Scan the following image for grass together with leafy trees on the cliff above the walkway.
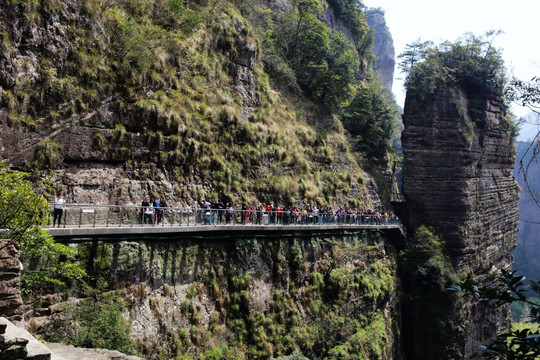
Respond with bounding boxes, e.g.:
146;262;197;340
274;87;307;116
2;0;384;205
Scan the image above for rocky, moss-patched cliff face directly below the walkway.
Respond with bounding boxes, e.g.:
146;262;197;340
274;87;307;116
39;232;399;359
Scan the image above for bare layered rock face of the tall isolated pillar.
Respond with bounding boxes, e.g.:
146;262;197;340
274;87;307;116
402;77;519;358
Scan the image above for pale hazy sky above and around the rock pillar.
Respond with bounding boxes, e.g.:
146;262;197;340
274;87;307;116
363;0;540;116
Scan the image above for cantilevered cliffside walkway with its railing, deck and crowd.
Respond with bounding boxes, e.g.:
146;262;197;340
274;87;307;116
47;204;404;242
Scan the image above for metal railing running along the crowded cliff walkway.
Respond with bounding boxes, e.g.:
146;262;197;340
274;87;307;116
49;204;401;227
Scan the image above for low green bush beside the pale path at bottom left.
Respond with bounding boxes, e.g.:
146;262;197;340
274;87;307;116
44;293;137;354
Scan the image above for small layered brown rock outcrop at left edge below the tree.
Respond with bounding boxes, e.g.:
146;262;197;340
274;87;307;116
0;240;23;320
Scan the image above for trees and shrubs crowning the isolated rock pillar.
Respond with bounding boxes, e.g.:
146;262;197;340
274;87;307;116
399;31;506;99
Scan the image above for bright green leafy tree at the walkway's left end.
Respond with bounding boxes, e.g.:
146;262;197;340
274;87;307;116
0;162;86;291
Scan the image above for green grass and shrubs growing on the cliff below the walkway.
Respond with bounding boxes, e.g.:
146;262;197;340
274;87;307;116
125;238;396;359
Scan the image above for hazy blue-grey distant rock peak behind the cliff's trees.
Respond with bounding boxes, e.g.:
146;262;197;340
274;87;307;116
366;9;396;91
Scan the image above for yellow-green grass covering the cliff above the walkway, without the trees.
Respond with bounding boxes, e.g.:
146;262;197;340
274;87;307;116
0;0;396;207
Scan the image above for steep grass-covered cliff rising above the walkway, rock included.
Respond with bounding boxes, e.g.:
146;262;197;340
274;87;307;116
0;0;388;207
